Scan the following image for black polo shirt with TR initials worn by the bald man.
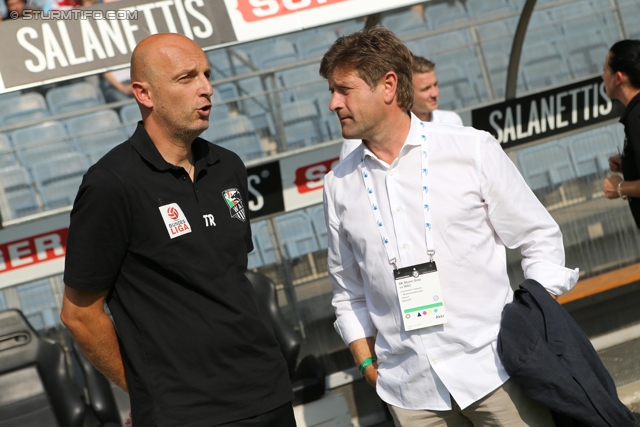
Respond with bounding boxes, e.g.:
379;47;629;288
64;124;293;427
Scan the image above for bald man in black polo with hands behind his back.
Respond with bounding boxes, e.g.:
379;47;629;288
61;34;295;427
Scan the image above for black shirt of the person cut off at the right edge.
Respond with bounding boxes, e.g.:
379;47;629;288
620;93;640;228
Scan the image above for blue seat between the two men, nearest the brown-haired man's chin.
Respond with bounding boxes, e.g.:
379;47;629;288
281;101;324;148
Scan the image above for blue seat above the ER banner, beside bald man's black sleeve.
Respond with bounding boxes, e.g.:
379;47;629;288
33;153;90;210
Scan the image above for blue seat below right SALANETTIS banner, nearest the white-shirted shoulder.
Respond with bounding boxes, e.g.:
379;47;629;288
518;142;576;191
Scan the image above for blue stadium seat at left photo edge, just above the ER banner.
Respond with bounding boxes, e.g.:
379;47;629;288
0;165;40;219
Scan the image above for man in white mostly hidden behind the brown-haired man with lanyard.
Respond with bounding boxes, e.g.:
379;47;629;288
340;55;462;160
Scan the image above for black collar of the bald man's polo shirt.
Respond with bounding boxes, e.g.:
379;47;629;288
129;121;219;171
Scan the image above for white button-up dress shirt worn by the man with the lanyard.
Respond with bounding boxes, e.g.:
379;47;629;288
324;114;578;410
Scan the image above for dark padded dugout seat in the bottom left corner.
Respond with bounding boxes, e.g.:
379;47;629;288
0;309;85;427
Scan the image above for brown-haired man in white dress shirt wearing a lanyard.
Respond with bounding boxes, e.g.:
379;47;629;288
320;27;578;427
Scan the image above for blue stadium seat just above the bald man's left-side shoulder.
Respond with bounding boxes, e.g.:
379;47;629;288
65;110;127;163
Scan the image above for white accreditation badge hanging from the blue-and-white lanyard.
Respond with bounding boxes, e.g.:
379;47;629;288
393;262;447;331
